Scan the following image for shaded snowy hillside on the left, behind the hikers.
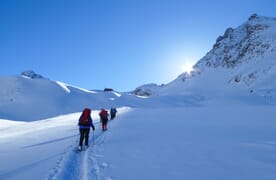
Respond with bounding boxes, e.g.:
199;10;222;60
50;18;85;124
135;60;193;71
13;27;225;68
0;72;126;121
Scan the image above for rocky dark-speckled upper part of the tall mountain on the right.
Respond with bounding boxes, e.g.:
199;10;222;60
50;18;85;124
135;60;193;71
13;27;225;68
196;14;276;70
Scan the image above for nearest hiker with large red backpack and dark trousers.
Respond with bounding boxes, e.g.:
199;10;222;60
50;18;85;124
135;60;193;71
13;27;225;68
78;108;95;150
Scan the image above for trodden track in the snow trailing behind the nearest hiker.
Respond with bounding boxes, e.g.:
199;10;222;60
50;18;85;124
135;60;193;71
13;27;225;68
46;123;112;180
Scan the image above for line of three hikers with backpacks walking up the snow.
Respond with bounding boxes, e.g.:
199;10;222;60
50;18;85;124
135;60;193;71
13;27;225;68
78;108;117;151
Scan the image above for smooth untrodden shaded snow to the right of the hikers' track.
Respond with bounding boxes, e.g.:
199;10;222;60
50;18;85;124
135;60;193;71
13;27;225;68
100;107;276;179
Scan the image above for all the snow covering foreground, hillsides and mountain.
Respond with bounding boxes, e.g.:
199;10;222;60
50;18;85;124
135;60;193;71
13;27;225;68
0;16;276;180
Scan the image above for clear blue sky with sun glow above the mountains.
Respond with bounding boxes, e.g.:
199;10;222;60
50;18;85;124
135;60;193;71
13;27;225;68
0;0;276;91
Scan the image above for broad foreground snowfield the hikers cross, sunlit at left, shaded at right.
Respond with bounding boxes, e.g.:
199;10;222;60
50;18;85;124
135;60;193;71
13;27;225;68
0;102;276;180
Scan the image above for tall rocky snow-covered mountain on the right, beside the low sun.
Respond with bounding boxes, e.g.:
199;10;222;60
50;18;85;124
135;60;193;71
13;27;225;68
134;14;276;97
